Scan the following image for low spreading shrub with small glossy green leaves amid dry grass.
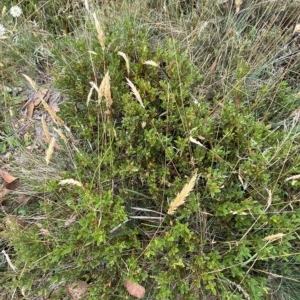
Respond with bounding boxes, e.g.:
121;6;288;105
3;0;300;299
